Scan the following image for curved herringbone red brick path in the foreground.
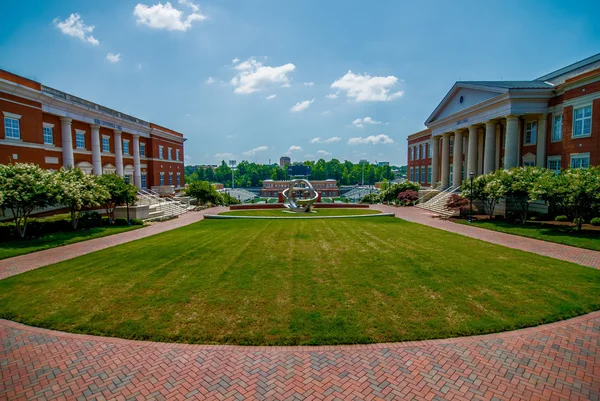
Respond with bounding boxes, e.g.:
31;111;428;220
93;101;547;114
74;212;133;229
0;312;600;400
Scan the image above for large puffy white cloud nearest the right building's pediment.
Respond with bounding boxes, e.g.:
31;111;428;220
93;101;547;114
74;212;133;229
331;71;404;102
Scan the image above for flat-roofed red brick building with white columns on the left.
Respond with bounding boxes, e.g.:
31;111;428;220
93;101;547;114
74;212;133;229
0;70;185;188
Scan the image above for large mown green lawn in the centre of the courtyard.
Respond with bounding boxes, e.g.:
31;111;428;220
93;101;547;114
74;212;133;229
0;218;600;344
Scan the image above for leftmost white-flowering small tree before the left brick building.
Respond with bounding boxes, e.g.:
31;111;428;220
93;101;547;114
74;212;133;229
0;163;57;238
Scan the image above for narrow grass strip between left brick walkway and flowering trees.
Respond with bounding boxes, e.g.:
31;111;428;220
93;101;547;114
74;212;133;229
0;226;141;259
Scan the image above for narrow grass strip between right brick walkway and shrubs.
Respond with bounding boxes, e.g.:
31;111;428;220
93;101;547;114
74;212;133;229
454;220;600;251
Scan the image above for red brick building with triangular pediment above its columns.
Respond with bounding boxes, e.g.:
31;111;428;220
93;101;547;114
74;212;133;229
408;54;600;188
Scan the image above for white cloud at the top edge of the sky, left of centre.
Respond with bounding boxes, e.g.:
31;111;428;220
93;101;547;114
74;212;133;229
133;0;206;31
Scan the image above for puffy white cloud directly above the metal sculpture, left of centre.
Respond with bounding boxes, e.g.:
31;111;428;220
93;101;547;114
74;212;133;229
231;58;296;94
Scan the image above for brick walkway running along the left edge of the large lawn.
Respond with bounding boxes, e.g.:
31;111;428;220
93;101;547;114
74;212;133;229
0;207;228;280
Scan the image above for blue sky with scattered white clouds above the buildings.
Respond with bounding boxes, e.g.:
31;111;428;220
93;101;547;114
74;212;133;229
0;0;600;164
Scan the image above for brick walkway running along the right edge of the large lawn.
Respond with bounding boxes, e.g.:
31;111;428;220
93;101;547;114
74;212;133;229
371;205;600;269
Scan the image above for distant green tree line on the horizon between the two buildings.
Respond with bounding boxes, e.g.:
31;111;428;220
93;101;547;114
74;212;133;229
185;159;406;188
